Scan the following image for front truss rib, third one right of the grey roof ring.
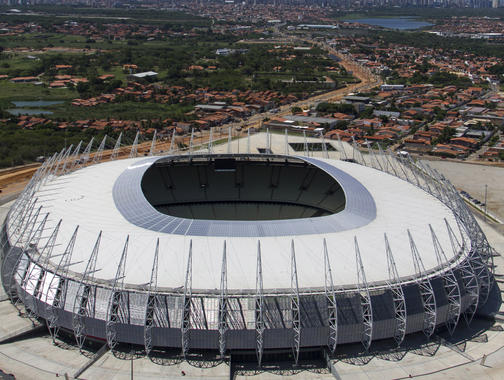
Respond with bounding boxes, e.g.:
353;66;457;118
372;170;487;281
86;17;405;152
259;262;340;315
429;224;462;335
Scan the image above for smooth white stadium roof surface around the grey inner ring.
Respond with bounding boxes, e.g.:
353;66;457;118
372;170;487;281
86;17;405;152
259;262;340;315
34;152;456;293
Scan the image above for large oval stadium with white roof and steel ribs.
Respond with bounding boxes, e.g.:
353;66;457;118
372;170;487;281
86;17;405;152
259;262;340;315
0;132;493;365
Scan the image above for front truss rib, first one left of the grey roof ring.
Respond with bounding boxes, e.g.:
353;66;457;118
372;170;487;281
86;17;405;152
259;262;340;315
72;231;102;350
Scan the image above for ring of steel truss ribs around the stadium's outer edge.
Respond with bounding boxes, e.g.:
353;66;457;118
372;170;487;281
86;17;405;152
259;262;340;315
2;134;500;360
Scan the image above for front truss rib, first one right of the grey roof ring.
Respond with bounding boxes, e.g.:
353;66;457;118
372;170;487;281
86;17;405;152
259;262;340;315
383;234;408;347
